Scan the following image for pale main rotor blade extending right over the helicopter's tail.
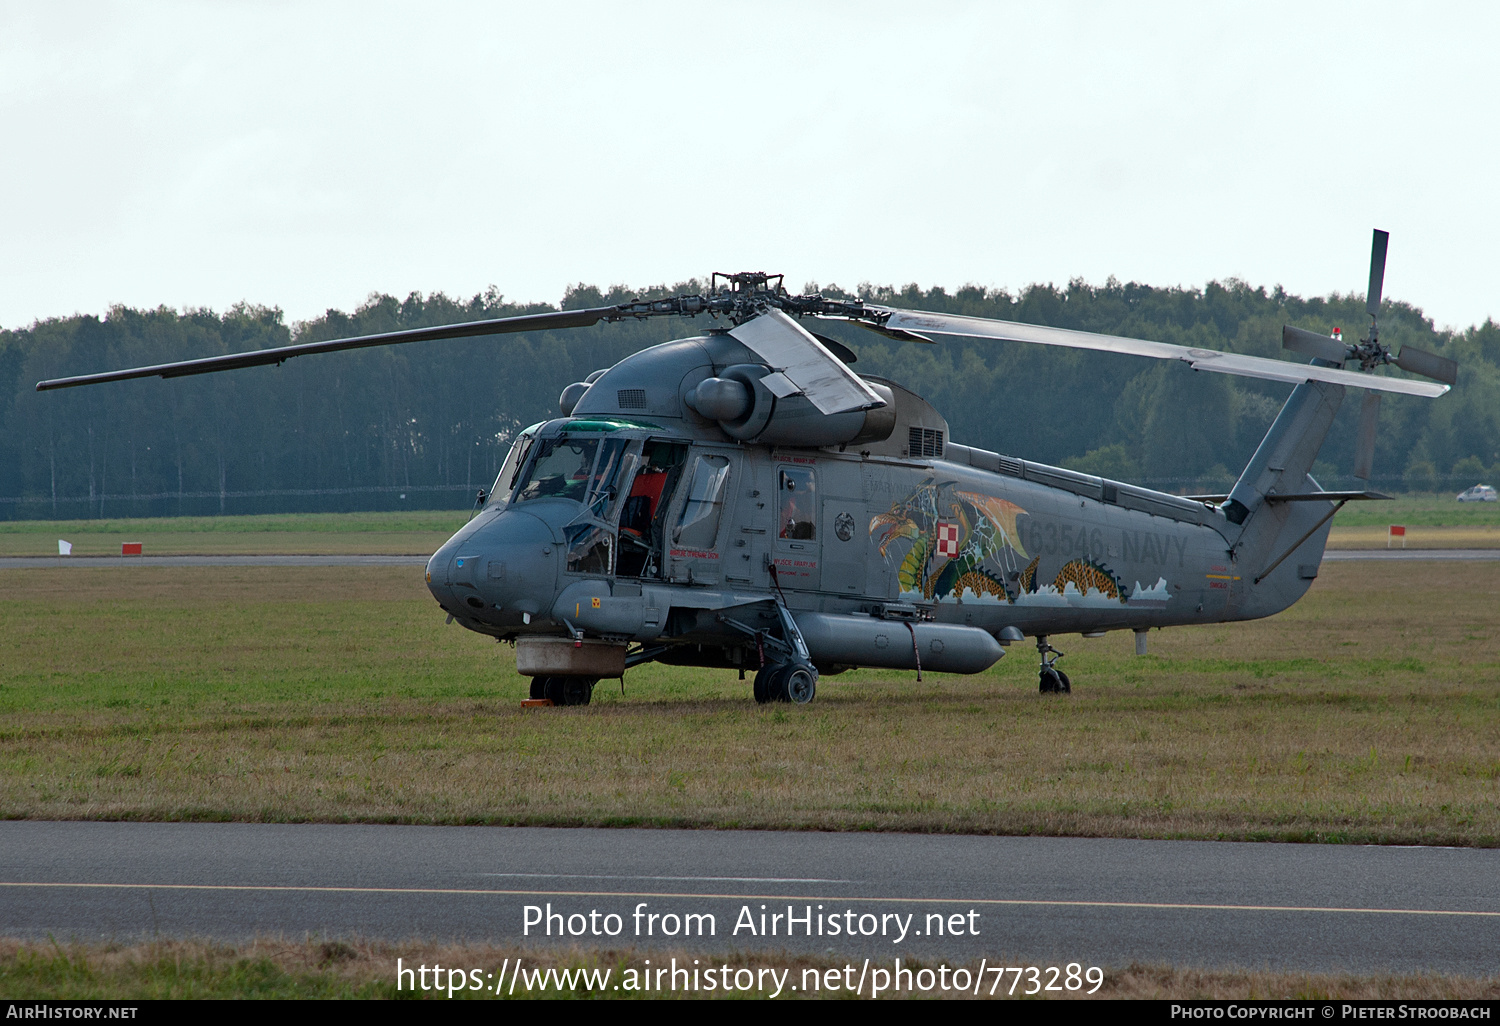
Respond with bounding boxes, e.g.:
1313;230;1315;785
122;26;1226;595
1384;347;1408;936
870;306;1448;398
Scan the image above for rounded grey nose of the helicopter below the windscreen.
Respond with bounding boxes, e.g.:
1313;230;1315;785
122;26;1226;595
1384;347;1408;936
428;510;561;626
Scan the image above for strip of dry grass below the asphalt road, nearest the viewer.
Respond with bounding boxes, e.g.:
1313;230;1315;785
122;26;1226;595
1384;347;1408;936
0;938;1500;1001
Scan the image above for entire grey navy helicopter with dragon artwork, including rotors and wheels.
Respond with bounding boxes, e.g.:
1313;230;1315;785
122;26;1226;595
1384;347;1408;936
36;230;1457;705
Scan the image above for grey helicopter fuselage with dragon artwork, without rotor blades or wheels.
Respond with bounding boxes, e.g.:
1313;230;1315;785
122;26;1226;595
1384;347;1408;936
428;333;1341;672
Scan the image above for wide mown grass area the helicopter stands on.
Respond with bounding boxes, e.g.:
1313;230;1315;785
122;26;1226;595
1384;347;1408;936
0;564;1500;846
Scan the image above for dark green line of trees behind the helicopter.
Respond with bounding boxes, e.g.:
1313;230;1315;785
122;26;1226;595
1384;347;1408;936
0;279;1500;519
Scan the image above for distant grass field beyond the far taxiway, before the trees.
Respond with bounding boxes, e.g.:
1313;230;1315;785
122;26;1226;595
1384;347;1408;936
0;494;1500;557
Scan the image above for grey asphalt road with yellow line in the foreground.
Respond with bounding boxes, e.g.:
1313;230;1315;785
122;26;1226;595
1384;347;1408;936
0;821;1500;975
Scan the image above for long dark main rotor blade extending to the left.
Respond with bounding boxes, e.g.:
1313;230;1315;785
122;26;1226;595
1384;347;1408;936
36;306;617;392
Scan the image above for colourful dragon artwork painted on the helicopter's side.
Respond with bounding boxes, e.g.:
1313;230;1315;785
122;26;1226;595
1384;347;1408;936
870;477;1127;603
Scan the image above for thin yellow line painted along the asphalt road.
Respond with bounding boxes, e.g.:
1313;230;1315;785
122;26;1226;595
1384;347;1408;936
0;881;1500;918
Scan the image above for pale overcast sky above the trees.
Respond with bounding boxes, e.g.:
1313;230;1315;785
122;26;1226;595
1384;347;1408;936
0;0;1500;327
